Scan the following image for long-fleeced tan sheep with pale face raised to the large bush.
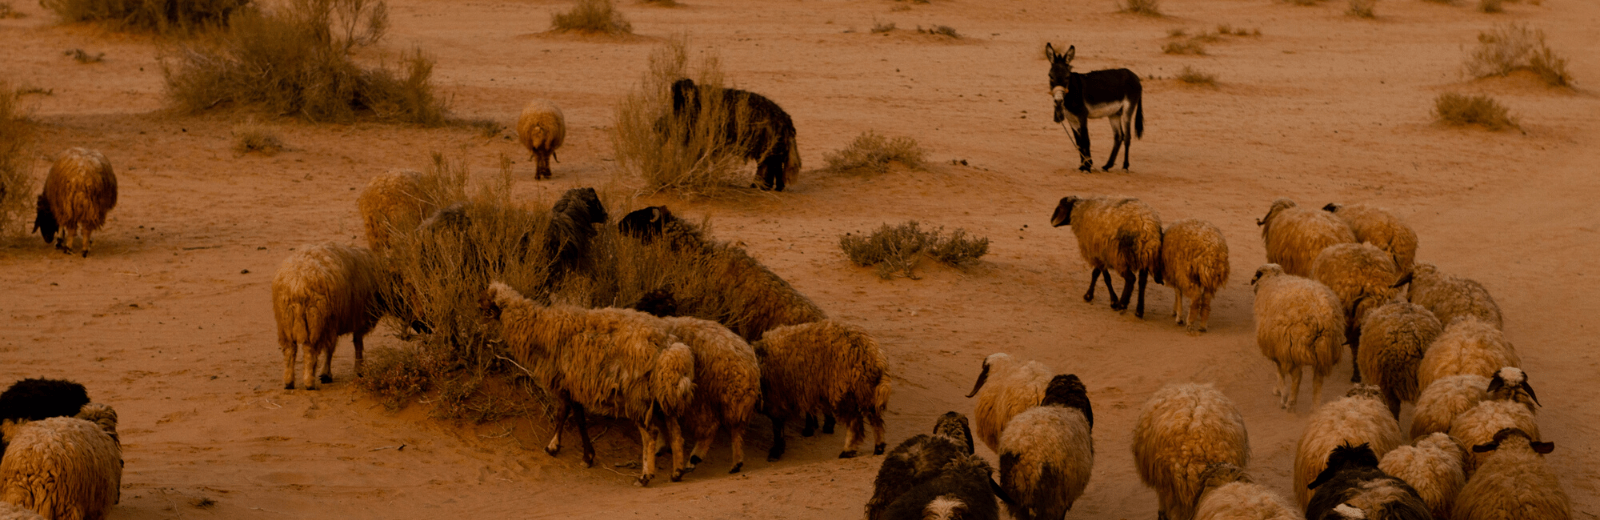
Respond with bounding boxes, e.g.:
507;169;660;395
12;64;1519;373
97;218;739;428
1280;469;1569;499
478;282;694;486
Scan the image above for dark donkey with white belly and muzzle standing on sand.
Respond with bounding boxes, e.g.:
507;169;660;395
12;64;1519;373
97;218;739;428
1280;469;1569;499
1045;43;1144;171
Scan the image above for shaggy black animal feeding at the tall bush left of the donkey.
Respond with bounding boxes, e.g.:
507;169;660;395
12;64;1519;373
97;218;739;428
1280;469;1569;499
672;78;800;192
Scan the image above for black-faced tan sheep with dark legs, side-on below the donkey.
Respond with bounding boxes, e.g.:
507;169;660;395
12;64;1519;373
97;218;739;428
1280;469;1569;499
1050;197;1163;318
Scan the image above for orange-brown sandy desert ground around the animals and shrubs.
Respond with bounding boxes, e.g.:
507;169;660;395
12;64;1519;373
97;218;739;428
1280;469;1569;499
0;0;1600;518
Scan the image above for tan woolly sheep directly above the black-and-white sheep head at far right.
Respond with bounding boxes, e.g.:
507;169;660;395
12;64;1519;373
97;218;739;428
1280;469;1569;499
1416;317;1522;390
